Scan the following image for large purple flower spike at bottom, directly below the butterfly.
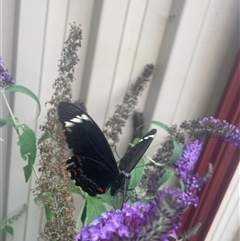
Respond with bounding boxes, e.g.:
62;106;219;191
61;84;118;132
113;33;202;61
75;192;186;241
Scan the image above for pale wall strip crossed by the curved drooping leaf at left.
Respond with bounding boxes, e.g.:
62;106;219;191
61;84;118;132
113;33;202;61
7;1;46;240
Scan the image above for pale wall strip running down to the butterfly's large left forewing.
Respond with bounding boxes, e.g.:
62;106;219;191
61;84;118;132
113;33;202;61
86;0;129;127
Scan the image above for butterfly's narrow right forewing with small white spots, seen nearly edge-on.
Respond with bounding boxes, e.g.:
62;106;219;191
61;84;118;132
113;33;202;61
119;129;157;173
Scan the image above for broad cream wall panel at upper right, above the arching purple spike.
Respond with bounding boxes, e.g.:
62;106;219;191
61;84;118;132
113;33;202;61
149;0;238;141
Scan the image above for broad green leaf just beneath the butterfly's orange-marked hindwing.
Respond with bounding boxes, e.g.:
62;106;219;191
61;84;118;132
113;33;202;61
86;196;106;224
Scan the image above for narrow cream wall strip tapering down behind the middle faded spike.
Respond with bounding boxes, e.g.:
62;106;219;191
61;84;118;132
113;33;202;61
108;0;147;115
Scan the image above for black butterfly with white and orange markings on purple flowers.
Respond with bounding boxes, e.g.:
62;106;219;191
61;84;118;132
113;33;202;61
58;102;157;196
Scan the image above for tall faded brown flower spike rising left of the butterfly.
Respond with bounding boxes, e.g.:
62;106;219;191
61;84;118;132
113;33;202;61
35;24;82;241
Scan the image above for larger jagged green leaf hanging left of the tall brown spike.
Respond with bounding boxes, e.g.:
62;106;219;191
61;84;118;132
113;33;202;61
17;125;37;165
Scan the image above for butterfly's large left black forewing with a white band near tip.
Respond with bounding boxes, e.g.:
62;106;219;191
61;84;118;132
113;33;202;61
58;102;118;175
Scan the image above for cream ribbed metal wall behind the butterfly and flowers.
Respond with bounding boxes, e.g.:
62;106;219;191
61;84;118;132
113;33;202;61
0;0;239;241
